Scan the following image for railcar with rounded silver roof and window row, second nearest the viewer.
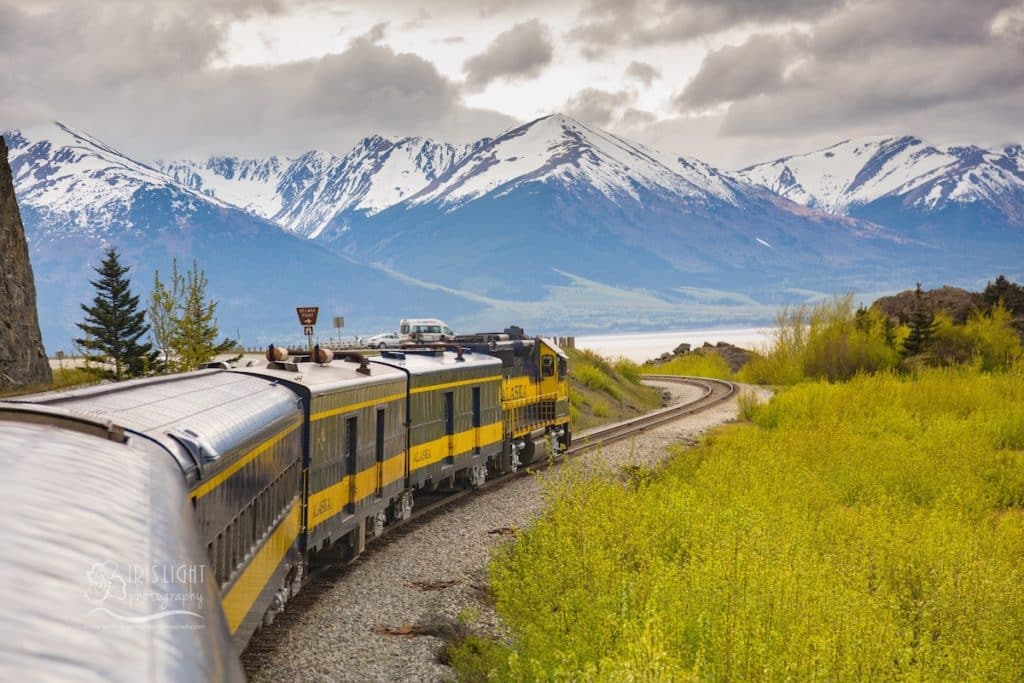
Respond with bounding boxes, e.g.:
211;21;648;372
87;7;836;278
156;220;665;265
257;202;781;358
12;371;305;650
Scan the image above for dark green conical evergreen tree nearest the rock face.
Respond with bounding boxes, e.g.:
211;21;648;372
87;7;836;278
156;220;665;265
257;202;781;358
75;247;156;380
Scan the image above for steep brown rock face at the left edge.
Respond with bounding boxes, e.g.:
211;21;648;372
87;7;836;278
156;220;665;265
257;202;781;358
0;137;52;392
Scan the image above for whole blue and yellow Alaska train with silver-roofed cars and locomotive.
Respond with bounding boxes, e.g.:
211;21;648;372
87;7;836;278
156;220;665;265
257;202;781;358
0;327;571;680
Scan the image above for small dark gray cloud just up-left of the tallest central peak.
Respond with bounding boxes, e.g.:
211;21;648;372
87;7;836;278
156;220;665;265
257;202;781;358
464;19;554;90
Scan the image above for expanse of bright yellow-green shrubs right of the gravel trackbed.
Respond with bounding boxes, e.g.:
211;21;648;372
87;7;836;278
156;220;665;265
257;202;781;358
460;364;1024;681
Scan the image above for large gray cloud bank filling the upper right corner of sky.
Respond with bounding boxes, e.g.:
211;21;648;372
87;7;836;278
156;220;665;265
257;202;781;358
674;0;1024;149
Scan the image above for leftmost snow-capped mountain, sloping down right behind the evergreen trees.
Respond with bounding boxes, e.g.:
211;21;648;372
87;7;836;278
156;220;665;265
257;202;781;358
4;124;479;351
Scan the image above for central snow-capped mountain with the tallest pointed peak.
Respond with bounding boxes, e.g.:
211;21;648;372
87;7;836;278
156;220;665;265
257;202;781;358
319;115;913;297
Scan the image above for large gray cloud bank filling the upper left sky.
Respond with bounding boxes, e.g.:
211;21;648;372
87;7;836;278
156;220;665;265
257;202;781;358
0;0;515;161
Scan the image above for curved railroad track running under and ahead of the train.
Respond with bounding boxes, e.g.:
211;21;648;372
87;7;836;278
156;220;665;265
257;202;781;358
242;375;735;677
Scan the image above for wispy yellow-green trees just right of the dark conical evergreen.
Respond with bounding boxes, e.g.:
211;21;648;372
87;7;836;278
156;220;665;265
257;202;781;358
150;260;236;371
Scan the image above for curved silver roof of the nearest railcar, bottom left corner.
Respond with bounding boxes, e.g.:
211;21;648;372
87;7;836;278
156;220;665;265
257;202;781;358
0;413;243;682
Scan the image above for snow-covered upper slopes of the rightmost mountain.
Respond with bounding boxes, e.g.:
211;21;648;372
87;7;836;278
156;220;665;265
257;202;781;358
740;136;1024;225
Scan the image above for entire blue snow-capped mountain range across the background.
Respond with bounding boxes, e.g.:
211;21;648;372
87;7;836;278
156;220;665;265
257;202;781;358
5;115;1024;346
